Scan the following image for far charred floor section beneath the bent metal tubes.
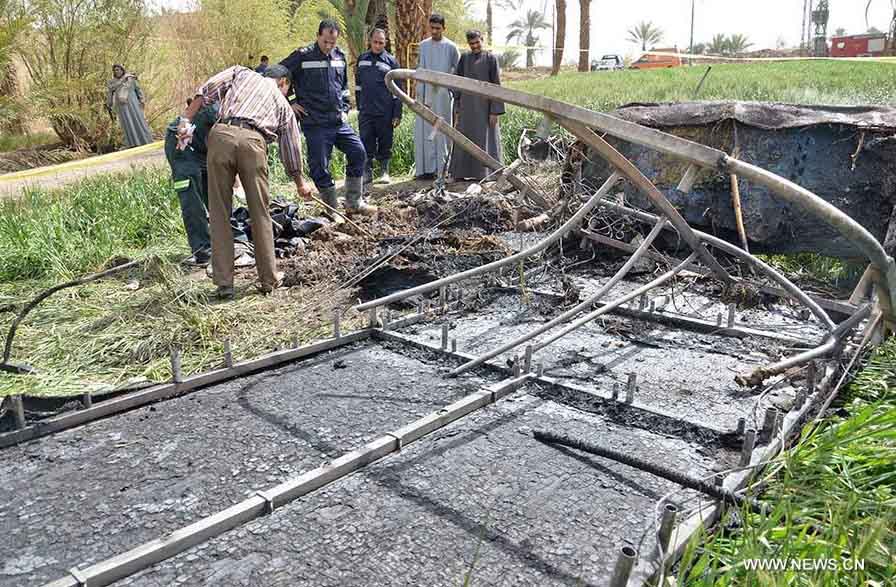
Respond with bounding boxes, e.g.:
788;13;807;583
406;282;780;432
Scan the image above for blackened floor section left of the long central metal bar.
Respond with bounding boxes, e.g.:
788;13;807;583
0;345;496;586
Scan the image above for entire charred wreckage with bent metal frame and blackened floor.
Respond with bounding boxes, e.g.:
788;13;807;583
0;70;896;587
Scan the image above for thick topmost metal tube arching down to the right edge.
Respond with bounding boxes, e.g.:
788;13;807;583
386;69;896;300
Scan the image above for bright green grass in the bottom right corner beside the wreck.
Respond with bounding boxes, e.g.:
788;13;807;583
676;339;896;587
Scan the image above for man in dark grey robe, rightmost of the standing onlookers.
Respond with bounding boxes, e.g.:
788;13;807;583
450;31;504;180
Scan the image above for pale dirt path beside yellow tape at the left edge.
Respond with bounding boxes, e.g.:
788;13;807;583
0;141;165;198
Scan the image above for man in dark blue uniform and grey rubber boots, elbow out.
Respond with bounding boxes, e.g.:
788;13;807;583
281;20;376;214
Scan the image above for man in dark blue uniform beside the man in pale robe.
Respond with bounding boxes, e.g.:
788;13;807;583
355;29;401;183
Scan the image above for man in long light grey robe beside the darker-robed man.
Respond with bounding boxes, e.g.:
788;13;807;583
414;13;460;179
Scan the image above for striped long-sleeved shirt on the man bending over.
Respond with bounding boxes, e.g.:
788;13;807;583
196;65;302;178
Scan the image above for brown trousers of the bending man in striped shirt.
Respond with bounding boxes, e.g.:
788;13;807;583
208;124;277;287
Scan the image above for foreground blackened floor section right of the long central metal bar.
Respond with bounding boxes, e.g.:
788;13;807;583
120;391;732;587
